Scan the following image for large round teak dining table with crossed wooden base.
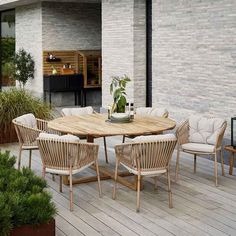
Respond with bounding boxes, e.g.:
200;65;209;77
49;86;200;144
48;113;176;190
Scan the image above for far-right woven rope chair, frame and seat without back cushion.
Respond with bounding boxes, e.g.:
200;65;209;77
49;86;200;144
175;116;227;186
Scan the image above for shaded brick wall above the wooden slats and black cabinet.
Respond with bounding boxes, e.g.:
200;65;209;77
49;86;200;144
42;2;101;50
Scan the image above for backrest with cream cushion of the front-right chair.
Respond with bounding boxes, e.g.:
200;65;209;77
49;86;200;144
115;134;177;171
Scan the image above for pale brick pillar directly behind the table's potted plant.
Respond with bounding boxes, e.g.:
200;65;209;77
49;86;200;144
102;0;146;106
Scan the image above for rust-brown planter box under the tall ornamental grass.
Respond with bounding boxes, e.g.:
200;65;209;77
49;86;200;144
0;123;18;144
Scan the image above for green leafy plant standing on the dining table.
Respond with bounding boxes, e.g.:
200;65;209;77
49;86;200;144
110;75;131;113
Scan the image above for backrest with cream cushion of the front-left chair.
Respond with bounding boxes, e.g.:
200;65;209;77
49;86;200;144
37;135;99;170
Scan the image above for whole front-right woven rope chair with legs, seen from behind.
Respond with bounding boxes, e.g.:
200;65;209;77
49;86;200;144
113;137;177;212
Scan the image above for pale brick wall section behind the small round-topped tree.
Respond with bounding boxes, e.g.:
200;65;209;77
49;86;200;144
16;3;43;96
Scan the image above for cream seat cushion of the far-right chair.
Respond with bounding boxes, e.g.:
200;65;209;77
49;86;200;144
181;143;215;153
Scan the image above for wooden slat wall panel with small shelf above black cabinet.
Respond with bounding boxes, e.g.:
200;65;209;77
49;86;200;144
43;51;78;75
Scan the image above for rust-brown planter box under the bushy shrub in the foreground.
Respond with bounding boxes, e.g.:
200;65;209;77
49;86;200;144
10;219;55;236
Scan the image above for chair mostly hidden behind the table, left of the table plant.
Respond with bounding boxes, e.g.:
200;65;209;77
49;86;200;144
61;106;108;163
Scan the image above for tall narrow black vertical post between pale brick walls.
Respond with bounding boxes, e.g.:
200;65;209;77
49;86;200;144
146;0;152;107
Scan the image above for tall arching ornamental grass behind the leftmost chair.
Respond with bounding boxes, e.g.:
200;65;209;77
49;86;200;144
0;88;51;124
